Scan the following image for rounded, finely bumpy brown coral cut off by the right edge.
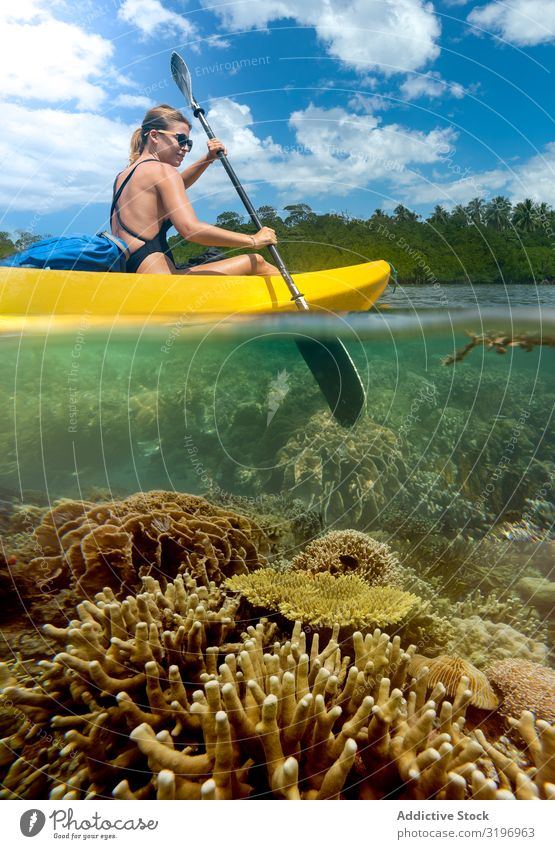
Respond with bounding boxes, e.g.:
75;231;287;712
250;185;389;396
485;658;555;722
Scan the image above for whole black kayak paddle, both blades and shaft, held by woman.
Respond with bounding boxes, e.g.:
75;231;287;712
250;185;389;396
171;53;365;427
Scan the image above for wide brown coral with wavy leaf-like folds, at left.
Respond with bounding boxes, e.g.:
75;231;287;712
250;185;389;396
30;491;266;595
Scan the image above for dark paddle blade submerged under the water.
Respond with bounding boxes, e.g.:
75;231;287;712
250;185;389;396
295;338;366;427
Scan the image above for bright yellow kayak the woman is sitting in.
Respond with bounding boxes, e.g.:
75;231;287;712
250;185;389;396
0;260;391;327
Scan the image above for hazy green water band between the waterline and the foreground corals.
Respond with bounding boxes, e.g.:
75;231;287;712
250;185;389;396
0;308;555;532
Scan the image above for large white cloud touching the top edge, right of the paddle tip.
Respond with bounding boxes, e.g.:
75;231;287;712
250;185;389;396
202;0;440;74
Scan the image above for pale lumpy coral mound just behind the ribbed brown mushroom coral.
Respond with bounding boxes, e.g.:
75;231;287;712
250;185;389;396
447;616;547;669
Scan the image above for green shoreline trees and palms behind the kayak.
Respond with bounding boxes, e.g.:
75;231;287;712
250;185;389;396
4;195;555;285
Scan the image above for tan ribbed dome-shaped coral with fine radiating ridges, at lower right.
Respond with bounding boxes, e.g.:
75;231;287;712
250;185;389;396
409;654;499;710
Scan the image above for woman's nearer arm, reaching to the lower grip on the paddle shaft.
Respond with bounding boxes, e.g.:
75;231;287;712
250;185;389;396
156;163;277;248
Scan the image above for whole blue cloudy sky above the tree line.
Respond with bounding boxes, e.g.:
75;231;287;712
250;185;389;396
0;0;555;234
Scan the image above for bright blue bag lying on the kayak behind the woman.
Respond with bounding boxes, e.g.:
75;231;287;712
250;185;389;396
0;231;129;271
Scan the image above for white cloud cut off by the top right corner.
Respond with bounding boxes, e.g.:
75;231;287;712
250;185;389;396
467;0;555;47
